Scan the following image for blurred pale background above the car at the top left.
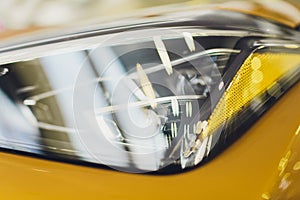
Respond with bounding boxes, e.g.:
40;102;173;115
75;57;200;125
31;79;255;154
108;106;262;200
0;0;299;31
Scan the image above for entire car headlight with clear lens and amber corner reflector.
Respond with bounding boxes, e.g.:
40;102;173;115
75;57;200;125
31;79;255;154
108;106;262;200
0;10;300;172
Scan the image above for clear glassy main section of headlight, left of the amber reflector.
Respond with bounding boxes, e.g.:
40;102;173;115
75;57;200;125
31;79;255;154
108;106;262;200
0;33;233;172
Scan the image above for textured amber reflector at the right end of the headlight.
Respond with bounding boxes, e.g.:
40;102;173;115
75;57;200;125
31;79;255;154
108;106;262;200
202;53;300;138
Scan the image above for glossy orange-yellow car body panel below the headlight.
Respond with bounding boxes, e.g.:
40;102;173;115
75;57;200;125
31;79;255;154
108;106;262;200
0;84;300;200
